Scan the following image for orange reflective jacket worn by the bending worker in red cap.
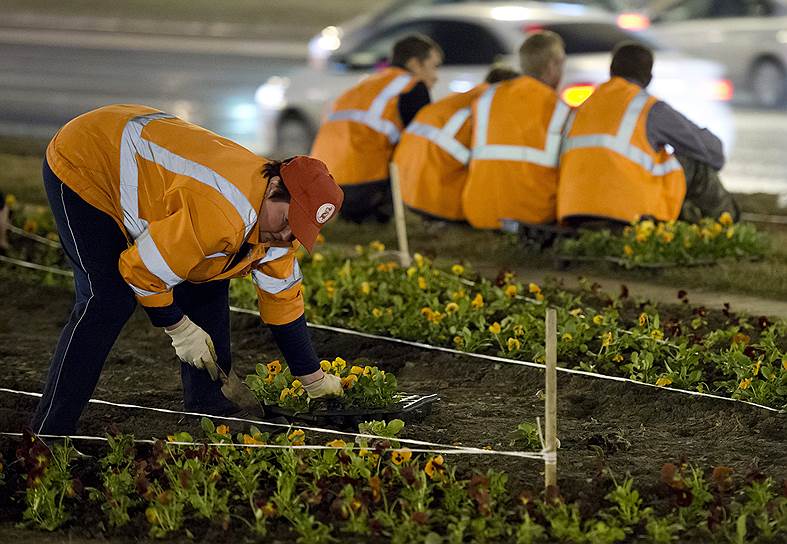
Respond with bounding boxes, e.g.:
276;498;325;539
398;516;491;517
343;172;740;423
46;105;303;325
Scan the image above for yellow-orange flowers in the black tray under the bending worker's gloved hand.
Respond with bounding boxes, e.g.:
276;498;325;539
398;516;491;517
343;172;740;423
246;357;396;413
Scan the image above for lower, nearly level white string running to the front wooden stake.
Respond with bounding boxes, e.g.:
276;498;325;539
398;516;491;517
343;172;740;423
0;434;544;460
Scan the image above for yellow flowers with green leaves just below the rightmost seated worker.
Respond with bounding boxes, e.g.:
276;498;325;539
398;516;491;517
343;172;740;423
558;216;768;268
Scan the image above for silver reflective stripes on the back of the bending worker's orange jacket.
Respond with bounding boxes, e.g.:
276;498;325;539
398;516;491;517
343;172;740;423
120;113;257;296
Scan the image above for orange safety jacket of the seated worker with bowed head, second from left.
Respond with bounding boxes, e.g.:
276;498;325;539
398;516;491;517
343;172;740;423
393;83;488;221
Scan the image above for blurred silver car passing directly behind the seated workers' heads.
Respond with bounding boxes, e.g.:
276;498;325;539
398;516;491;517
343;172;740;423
255;2;733;156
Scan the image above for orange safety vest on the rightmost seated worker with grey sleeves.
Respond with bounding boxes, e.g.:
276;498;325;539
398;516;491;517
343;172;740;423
557;77;686;222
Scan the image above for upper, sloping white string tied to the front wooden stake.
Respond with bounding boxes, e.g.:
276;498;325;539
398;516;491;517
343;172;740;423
0;387;543;459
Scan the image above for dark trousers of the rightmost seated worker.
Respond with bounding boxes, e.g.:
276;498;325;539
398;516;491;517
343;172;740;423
675;154;740;223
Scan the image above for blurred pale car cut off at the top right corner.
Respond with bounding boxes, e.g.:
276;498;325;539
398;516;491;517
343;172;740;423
650;0;787;107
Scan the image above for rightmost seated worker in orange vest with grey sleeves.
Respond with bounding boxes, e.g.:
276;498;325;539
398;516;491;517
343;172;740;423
557;42;738;226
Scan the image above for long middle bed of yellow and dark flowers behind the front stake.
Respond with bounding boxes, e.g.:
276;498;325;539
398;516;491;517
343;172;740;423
232;243;787;408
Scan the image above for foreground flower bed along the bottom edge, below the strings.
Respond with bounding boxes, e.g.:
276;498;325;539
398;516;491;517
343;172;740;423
0;419;787;543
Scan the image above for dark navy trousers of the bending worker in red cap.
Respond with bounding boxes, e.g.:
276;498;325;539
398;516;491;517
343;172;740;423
31;161;234;434
